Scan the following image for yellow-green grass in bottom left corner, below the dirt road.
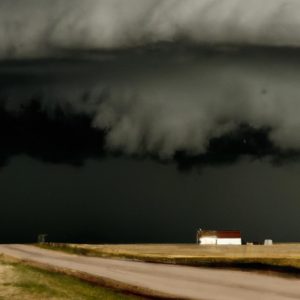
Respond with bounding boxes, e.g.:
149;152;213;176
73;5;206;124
0;256;140;300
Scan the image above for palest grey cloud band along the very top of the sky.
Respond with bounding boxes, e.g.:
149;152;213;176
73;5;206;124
0;0;300;58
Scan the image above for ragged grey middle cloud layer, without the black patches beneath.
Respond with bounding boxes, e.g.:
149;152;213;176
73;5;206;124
0;46;300;159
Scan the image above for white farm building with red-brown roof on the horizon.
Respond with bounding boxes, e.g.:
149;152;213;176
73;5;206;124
197;229;242;245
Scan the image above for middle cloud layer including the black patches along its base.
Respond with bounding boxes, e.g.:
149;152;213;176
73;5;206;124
0;44;300;169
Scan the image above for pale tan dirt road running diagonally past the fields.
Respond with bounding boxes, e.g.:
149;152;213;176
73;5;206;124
0;245;300;300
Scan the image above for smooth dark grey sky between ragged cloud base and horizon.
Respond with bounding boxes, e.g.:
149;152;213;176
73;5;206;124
0;156;300;243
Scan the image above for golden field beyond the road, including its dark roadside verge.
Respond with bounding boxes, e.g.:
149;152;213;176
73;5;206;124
38;243;300;274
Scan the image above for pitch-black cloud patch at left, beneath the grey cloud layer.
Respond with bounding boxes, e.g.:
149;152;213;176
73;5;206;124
0;100;104;167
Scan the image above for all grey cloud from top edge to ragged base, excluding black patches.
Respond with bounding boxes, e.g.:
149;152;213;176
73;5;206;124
0;0;300;163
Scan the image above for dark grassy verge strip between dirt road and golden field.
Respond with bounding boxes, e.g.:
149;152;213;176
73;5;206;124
35;243;300;276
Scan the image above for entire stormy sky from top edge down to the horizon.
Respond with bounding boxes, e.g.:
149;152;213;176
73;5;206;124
0;0;300;243
